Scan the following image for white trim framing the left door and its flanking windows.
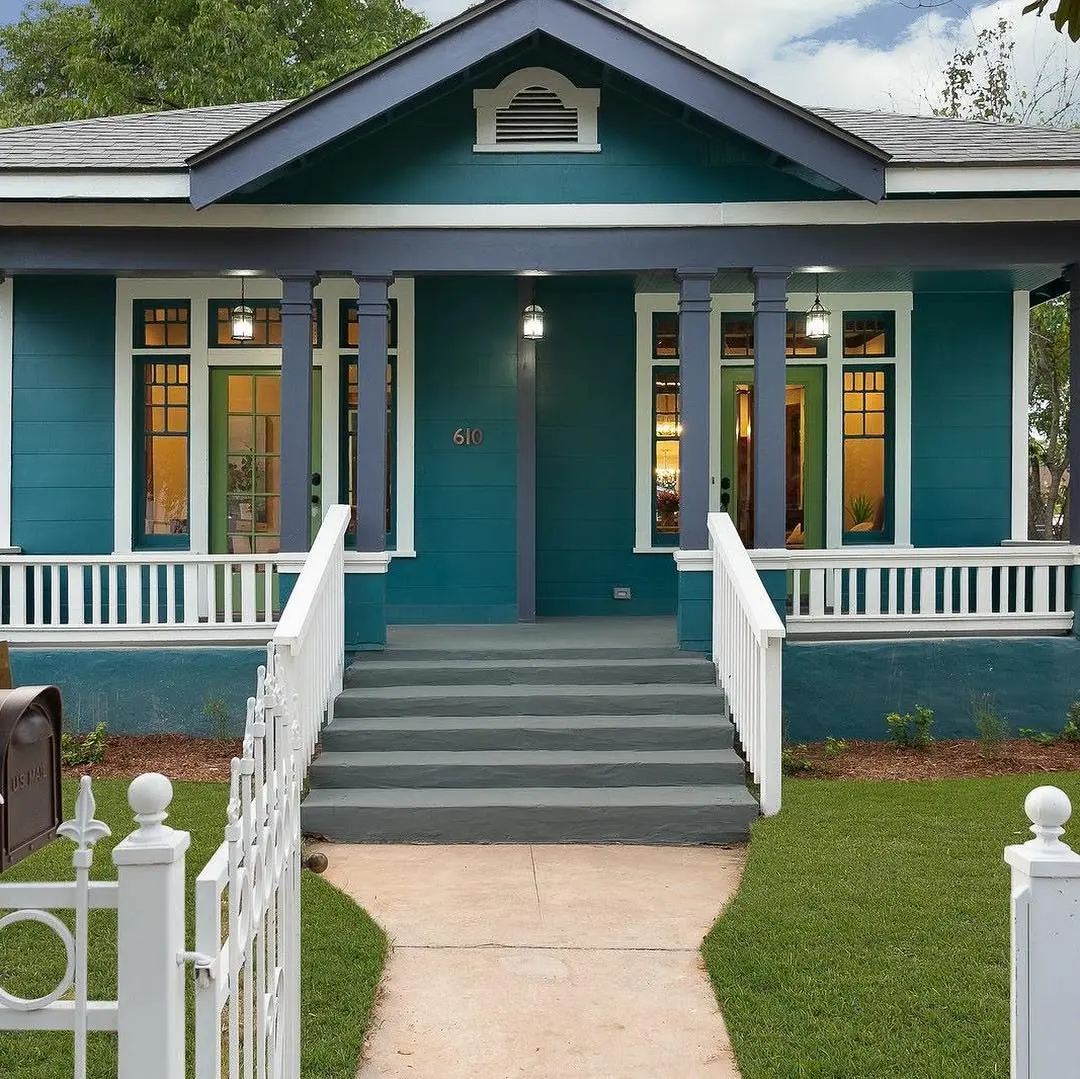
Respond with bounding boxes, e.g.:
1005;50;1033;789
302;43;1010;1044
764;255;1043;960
111;277;415;558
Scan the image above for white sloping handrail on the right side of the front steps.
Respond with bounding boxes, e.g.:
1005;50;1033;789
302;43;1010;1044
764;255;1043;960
708;513;785;817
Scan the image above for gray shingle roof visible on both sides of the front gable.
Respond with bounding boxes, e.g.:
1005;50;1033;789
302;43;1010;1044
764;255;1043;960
0;102;1080;171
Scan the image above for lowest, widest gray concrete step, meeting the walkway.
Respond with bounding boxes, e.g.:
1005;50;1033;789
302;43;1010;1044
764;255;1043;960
301;784;758;846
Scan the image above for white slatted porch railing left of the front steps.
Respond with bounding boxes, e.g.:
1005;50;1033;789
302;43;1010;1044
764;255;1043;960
0;552;302;644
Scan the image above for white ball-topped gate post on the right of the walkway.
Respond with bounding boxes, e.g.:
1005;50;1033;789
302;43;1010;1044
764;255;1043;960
1004;786;1080;1079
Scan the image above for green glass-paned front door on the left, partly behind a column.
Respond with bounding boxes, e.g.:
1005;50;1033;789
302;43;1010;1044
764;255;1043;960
210;367;322;554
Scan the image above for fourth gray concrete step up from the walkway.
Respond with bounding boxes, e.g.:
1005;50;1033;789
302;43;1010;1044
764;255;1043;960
334;685;725;717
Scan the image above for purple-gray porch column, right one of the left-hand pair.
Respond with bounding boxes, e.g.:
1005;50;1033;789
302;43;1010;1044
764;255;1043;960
354;273;393;552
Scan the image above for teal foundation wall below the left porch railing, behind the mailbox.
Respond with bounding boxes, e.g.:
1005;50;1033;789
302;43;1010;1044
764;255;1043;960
11;647;267;737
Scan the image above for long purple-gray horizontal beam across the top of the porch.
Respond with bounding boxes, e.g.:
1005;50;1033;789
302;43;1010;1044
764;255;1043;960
14;221;1080;274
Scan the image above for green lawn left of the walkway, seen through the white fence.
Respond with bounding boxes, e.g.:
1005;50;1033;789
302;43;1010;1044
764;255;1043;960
0;779;387;1079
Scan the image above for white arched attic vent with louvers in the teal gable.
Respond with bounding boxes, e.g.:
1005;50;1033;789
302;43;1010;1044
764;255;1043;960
473;67;600;153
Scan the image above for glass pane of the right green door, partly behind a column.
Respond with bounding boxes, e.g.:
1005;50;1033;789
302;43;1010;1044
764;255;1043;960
734;383;807;548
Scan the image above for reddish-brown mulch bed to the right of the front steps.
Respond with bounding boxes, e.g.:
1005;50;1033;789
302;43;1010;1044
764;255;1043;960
793;739;1080;780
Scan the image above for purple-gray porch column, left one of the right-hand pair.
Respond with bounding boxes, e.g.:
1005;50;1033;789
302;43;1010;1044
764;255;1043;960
678;269;716;551
